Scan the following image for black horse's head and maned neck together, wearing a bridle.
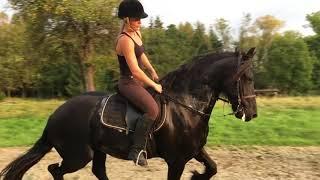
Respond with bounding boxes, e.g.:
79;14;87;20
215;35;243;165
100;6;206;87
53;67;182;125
161;48;257;121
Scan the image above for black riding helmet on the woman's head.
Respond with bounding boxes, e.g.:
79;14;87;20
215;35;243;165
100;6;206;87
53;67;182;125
118;0;148;19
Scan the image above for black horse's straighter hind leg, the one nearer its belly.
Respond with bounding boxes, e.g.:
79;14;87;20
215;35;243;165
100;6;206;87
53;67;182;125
92;150;108;180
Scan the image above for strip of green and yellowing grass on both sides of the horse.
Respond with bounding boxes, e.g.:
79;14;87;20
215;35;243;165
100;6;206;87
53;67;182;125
0;96;320;147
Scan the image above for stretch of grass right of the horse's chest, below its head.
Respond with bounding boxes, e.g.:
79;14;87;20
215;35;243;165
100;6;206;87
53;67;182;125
207;97;320;146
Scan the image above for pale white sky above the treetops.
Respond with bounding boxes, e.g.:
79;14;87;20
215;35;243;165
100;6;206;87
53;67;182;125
0;0;320;35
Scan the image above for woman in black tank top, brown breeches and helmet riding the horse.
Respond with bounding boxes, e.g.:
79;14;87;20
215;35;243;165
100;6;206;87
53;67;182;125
116;0;162;166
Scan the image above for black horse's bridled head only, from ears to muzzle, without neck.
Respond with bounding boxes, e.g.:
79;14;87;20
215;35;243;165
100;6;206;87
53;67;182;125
222;48;257;121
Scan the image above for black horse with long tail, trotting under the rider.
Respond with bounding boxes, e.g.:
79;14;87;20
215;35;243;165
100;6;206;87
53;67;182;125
0;48;257;180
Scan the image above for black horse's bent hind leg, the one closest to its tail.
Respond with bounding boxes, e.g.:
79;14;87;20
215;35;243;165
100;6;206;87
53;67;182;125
48;149;92;180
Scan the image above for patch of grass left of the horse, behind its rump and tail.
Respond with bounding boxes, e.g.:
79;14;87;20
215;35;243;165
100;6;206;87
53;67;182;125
0;98;63;147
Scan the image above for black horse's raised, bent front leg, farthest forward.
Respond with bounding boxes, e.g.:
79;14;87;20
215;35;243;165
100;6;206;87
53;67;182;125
191;148;217;180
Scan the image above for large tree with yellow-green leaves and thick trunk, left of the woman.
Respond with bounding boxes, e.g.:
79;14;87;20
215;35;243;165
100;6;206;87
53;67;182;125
10;0;118;91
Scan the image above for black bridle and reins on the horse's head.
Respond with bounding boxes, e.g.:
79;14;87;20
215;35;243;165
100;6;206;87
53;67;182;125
160;53;256;118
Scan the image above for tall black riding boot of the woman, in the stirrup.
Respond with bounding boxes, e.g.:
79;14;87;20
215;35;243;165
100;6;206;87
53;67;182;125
128;116;153;166
